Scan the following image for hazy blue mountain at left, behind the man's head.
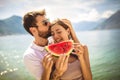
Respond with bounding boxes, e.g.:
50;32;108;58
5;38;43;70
0;15;26;35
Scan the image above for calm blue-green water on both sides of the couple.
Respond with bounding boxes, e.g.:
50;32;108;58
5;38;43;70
0;30;120;80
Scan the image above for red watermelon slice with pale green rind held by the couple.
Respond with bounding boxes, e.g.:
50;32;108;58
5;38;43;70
45;40;73;56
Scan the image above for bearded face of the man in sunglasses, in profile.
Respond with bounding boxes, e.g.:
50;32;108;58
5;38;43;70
36;16;50;38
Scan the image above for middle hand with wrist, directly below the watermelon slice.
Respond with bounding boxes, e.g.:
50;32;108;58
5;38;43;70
53;54;69;77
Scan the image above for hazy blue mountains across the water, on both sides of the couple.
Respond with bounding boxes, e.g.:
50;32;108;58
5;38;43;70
0;10;120;35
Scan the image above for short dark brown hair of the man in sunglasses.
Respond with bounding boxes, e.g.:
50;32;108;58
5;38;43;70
23;10;46;35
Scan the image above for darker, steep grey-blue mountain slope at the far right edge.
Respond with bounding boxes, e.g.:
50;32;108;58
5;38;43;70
95;10;120;30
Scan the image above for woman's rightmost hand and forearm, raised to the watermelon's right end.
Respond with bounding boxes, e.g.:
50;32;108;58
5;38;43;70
74;43;92;80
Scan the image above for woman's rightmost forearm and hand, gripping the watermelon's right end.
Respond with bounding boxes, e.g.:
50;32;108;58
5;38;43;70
75;44;92;80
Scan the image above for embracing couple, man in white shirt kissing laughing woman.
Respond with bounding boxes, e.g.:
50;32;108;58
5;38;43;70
23;10;92;80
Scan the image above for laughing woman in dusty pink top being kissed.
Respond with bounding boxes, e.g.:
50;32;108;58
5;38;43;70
42;20;92;80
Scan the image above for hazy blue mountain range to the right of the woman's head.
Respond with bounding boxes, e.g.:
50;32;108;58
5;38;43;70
73;10;120;31
